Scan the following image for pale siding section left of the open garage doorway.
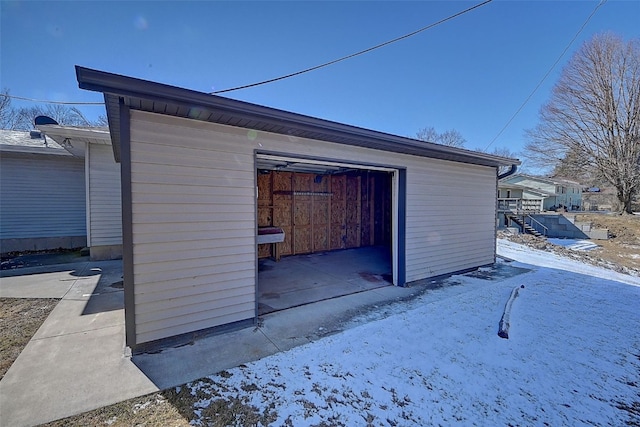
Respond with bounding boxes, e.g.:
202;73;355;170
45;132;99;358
131;112;256;343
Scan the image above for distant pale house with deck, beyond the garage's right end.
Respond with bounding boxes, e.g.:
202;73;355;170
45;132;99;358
498;174;582;224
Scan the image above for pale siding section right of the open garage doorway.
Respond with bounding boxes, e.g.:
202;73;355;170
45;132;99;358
406;161;497;281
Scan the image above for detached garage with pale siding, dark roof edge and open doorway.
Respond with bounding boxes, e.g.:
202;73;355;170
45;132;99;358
76;67;518;351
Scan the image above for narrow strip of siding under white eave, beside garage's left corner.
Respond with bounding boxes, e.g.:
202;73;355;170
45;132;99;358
88;144;122;247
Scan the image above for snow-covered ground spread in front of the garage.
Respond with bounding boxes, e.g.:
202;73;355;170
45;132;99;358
187;240;640;426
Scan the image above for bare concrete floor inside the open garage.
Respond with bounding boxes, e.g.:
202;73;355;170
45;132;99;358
258;246;392;315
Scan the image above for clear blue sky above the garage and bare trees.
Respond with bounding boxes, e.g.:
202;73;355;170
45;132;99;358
0;0;640;161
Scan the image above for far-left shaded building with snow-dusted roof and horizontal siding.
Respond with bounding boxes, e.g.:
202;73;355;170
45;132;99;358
0;130;87;254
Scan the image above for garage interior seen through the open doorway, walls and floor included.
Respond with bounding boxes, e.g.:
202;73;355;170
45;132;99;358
256;156;393;315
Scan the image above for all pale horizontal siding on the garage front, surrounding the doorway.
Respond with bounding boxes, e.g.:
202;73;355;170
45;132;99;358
131;111;496;343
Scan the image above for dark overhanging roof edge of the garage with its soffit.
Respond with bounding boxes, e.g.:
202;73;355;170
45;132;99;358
76;66;520;167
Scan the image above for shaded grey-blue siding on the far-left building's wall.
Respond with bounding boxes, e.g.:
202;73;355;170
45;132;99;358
0;152;87;239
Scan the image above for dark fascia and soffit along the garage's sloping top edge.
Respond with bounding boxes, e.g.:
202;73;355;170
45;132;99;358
76;66;520;167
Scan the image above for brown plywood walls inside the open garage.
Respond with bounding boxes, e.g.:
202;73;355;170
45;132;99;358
258;171;391;258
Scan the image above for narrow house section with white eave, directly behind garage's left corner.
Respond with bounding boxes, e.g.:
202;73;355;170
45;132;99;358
37;125;122;260
